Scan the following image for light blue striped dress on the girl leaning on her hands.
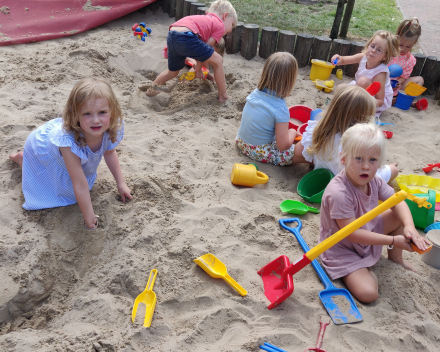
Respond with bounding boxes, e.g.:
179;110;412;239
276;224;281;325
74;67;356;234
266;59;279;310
22;118;124;210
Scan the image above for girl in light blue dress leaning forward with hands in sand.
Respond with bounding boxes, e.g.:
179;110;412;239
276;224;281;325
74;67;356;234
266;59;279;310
9;78;132;230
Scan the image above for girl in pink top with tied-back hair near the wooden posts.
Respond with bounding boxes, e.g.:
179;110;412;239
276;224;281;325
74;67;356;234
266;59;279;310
388;17;424;105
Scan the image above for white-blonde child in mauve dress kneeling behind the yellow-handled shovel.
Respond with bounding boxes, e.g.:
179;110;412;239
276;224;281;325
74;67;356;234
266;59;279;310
319;123;429;303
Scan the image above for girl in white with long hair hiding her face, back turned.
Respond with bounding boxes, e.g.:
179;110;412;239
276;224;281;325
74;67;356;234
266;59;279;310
293;85;399;182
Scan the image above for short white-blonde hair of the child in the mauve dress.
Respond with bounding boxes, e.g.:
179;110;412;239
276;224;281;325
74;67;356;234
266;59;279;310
339;123;386;168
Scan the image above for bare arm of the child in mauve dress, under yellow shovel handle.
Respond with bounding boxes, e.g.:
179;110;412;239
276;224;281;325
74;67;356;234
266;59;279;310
336;217;417;252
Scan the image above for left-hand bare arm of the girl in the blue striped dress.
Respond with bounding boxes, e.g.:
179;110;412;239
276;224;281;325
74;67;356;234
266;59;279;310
60;147;96;228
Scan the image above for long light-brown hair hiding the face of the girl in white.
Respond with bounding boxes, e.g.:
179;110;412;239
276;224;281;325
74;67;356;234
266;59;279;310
307;85;376;160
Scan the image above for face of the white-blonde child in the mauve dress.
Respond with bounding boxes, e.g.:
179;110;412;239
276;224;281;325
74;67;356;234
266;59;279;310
341;147;380;193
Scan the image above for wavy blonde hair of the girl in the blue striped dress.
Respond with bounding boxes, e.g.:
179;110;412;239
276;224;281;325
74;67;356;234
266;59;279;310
63;77;122;146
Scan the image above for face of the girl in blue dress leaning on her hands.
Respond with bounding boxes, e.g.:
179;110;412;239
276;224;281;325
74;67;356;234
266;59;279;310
79;98;111;140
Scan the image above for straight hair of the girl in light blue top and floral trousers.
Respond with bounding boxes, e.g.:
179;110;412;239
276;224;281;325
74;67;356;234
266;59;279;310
258;52;298;98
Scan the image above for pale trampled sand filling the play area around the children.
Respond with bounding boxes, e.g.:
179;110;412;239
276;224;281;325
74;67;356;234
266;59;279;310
0;6;440;352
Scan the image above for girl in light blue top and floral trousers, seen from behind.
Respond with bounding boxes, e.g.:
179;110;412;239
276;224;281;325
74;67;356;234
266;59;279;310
235;52;299;166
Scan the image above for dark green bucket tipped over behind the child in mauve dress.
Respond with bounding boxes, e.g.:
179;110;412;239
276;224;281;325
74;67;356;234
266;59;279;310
297;169;335;203
